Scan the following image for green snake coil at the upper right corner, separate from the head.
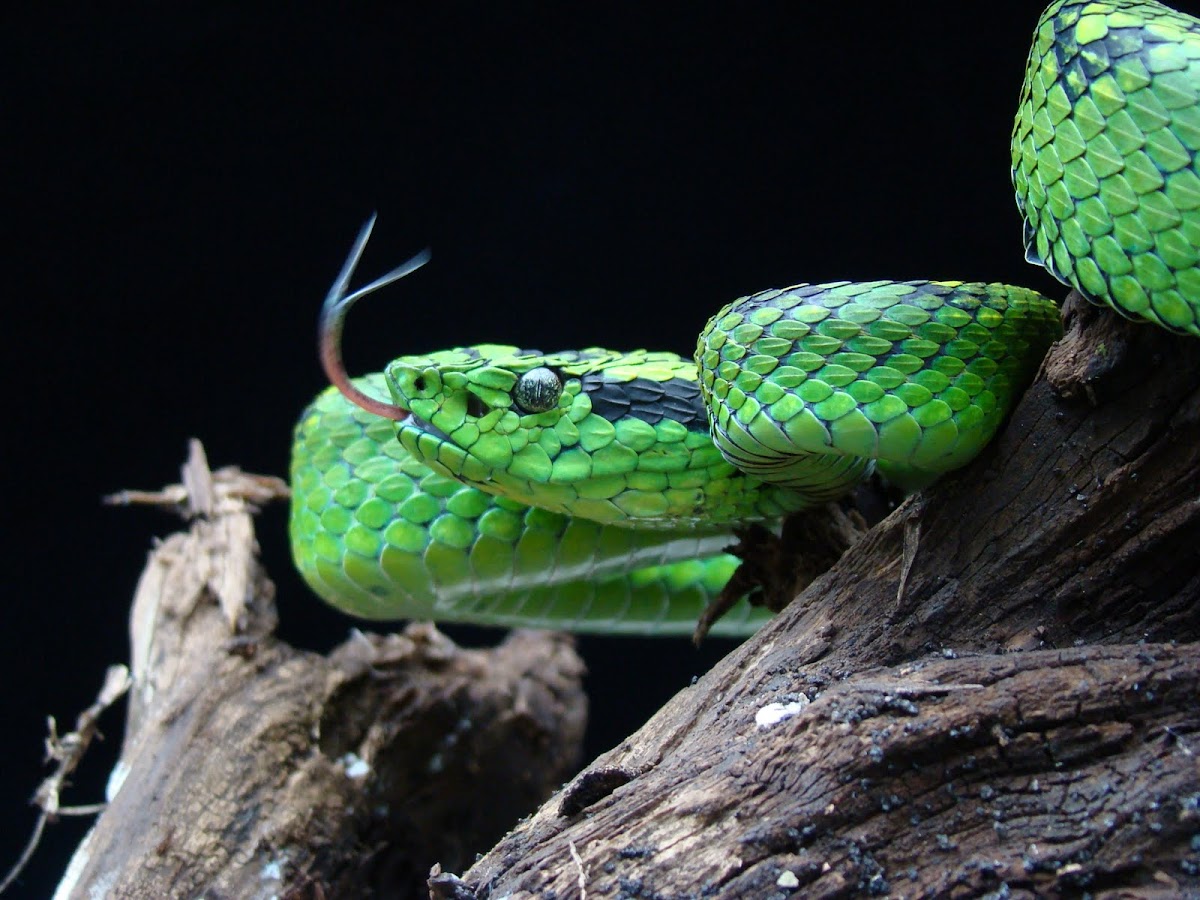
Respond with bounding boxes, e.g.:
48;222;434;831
1012;0;1200;336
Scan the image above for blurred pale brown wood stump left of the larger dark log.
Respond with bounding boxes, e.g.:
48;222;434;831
56;454;587;899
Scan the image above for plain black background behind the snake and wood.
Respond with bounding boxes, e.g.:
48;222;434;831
0;1;1123;896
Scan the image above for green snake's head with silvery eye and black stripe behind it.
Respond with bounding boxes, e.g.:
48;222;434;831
385;344;792;528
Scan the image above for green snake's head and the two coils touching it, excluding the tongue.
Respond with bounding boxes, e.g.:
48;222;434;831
292;282;1058;634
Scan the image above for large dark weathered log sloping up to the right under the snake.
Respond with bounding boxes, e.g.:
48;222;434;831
448;295;1200;899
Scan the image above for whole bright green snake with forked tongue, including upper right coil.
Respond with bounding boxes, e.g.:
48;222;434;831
290;0;1200;635
